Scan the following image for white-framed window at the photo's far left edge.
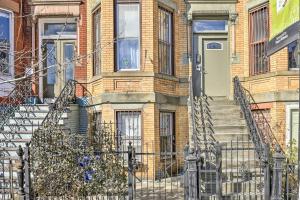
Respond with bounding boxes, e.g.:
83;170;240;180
0;9;14;74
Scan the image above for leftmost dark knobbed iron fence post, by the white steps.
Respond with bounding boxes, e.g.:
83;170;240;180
16;146;25;200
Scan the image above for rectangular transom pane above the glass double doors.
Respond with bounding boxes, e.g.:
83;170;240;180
44;23;77;35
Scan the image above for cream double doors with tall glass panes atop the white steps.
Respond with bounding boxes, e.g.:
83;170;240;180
43;40;75;99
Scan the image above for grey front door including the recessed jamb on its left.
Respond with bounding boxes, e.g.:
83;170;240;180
194;35;230;96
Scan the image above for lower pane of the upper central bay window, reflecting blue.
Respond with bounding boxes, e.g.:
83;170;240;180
118;38;140;69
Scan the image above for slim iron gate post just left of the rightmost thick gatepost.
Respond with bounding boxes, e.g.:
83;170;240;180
263;144;271;199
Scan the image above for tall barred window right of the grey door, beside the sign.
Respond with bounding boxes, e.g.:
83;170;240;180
249;5;270;75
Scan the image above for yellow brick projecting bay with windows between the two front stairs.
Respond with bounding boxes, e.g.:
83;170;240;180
87;0;190;175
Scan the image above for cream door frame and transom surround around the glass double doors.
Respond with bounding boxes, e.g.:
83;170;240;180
38;17;79;102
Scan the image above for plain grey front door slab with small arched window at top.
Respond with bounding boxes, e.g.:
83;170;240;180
202;39;230;96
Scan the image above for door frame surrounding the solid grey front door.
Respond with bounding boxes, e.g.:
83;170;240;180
192;32;231;97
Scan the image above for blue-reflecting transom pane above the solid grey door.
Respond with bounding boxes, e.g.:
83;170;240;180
193;20;227;33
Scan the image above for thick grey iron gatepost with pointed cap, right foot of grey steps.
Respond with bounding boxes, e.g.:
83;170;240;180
271;146;284;200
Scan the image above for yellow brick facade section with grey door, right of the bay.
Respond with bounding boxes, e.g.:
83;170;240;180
188;0;299;149
